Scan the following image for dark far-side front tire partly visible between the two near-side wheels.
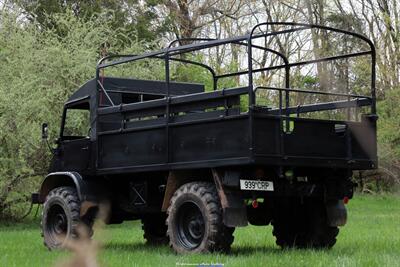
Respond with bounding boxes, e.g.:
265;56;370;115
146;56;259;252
142;213;169;246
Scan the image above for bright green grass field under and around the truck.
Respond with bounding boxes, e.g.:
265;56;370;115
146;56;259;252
0;195;400;267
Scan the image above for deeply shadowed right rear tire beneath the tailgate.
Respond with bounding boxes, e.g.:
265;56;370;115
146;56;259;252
272;199;339;249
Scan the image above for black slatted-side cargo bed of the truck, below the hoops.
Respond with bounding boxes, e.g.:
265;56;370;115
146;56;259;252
97;87;376;173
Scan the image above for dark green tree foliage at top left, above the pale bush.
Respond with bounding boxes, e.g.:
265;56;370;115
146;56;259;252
15;0;167;42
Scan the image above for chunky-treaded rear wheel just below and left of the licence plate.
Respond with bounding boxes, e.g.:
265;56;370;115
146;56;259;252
166;182;235;253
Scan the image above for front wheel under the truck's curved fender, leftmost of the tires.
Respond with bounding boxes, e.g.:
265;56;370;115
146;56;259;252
41;187;94;250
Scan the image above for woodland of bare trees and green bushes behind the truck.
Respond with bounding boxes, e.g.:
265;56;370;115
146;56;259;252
0;0;400;220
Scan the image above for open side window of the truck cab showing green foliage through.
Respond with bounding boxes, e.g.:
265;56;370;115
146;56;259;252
63;103;90;140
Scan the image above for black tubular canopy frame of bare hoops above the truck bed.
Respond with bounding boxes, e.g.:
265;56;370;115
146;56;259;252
96;22;376;116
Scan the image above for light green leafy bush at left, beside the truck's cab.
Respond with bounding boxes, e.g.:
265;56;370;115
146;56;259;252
0;12;159;218
